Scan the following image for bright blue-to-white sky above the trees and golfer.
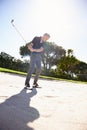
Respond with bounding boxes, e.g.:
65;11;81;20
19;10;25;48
0;0;87;62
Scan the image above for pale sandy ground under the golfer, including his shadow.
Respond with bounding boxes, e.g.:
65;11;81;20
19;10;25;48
0;73;87;130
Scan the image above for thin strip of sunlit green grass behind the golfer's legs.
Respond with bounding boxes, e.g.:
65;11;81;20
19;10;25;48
0;67;87;84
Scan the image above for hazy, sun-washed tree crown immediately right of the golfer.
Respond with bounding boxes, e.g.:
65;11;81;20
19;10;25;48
42;42;65;70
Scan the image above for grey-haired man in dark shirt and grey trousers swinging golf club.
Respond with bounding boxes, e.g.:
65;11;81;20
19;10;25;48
25;33;50;89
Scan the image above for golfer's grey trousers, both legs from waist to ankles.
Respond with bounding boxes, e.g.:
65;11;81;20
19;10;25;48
25;54;41;84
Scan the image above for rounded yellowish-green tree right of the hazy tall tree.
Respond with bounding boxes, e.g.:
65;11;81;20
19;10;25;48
57;49;79;78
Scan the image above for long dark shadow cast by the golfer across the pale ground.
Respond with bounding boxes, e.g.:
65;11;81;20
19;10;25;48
0;89;40;130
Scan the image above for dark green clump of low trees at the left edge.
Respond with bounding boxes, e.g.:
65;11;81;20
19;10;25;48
0;52;29;72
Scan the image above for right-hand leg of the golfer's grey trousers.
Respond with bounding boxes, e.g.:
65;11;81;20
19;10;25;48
34;58;41;83
